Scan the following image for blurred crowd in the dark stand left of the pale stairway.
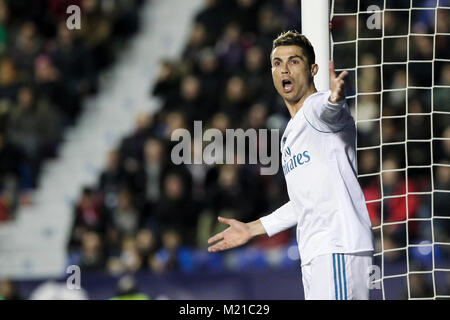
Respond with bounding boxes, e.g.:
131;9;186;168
0;0;143;222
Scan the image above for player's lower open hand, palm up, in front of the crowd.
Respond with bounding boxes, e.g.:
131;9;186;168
208;217;252;252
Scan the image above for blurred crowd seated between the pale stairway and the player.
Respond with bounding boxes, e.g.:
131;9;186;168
70;0;300;273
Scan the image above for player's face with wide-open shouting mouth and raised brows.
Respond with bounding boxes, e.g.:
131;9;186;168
271;46;318;103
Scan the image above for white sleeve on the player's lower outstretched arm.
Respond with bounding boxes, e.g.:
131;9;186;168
260;201;298;237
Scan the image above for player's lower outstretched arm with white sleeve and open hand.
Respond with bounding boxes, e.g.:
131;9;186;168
208;201;297;252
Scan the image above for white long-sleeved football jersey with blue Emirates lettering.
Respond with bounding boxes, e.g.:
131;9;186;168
261;91;374;265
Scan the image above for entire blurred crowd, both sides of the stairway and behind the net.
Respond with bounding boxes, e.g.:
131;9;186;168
0;0;450;300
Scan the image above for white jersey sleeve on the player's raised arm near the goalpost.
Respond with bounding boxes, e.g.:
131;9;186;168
303;91;352;133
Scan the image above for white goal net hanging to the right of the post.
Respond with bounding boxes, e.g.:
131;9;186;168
330;0;450;299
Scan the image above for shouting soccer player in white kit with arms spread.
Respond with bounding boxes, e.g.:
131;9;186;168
208;31;374;300
